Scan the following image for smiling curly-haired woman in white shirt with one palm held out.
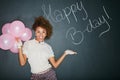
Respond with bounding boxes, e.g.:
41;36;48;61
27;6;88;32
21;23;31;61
18;16;75;80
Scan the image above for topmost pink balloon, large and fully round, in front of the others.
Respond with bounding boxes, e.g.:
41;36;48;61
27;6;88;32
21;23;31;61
10;20;25;37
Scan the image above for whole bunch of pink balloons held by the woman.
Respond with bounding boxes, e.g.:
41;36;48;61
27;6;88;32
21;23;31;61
0;20;32;53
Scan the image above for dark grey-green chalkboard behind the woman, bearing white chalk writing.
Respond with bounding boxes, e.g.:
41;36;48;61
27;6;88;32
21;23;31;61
0;0;120;80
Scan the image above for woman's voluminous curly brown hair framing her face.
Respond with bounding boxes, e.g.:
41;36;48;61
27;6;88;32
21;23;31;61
32;16;53;39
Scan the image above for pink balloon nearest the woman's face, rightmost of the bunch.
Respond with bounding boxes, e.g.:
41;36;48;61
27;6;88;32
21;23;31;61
20;28;32;41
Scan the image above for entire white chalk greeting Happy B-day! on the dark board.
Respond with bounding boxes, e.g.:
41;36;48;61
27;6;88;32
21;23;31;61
42;1;111;45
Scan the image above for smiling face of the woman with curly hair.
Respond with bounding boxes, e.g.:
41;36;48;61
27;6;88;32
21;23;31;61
35;26;47;42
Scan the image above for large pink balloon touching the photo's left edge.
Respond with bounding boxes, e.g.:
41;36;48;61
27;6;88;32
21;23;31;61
0;34;15;50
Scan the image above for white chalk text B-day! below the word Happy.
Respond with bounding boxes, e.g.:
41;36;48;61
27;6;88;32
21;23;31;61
66;6;111;45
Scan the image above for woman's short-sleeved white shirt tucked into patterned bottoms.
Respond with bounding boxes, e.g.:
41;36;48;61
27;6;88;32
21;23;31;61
23;39;54;73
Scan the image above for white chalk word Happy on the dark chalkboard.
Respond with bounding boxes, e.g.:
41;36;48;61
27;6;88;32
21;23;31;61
42;1;88;24
